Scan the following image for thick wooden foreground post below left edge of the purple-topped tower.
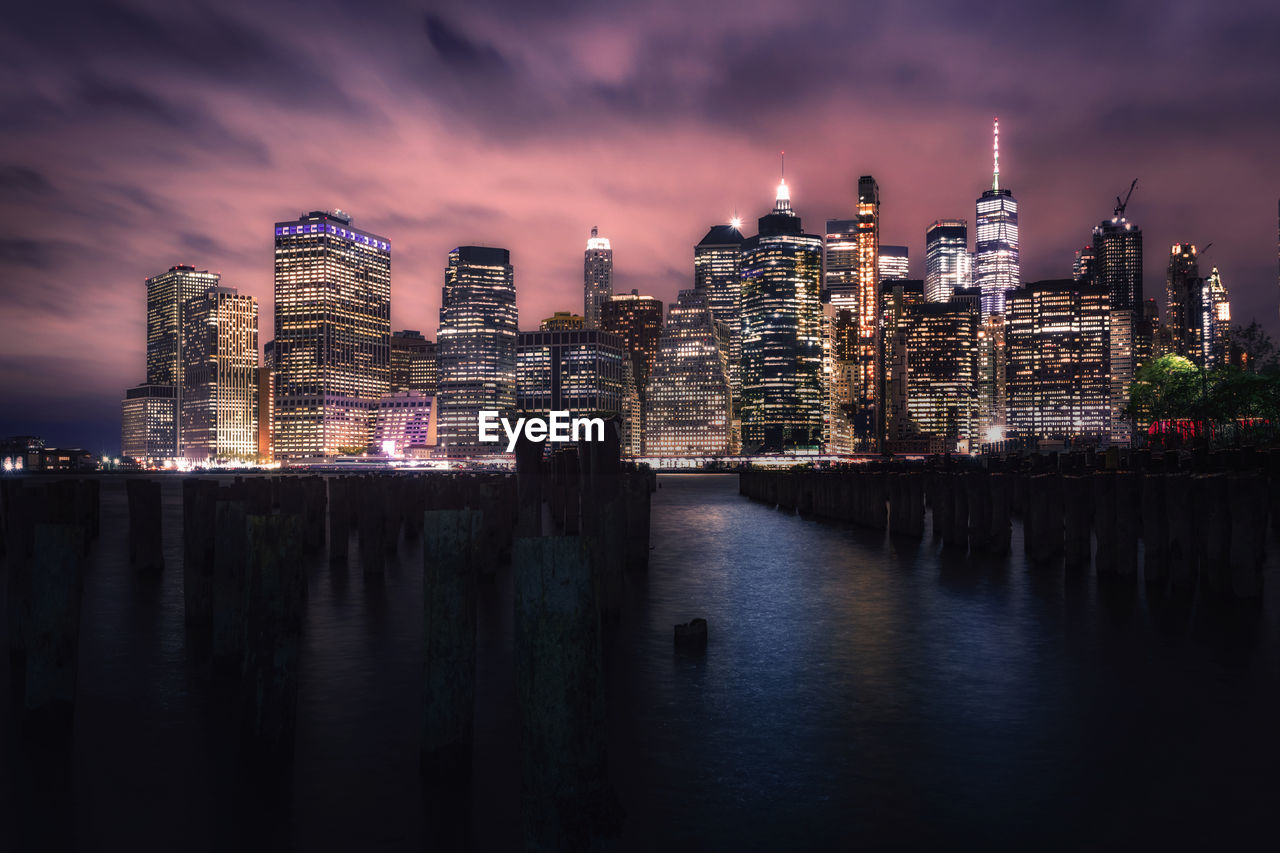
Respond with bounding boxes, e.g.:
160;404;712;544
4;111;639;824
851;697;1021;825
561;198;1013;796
241;515;305;762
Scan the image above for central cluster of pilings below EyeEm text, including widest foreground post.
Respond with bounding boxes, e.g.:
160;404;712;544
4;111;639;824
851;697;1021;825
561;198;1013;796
512;424;655;850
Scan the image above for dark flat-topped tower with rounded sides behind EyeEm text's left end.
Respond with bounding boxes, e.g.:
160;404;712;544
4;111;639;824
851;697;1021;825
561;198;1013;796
436;246;518;456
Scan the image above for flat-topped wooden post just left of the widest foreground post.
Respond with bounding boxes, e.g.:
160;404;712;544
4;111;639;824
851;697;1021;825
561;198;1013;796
421;510;484;788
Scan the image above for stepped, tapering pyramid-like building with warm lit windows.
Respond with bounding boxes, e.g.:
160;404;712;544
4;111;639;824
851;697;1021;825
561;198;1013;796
644;289;735;459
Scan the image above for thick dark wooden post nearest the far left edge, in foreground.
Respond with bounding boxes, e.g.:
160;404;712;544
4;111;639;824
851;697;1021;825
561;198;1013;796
23;524;87;729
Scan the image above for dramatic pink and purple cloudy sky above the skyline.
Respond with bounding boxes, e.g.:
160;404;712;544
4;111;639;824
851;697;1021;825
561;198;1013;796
0;0;1280;452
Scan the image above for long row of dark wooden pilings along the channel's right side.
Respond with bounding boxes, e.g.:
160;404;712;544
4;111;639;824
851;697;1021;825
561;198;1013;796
739;450;1280;598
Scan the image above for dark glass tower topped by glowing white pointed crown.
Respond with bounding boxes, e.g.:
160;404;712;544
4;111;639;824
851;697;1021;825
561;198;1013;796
742;174;819;452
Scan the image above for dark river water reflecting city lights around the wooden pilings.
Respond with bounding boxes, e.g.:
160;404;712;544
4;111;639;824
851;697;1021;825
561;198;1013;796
0;475;1280;850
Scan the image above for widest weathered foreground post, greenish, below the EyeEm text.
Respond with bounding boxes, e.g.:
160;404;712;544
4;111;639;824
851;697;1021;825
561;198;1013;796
513;537;621;850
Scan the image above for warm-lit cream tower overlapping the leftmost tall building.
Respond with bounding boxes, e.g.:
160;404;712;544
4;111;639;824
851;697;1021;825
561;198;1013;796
179;287;259;461
